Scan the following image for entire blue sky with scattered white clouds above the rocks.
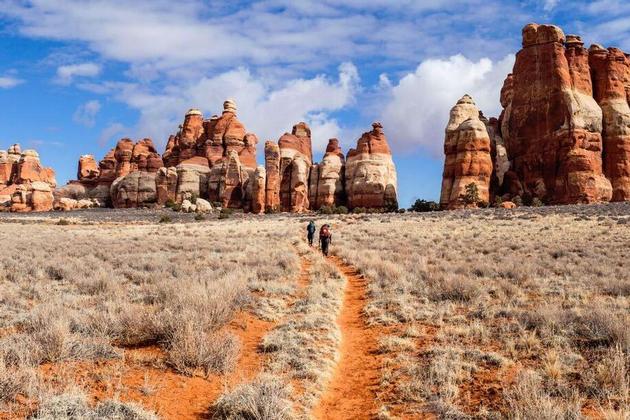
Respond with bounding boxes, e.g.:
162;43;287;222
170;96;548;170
0;0;630;206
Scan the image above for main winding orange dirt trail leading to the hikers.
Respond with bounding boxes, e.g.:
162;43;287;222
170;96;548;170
313;256;381;419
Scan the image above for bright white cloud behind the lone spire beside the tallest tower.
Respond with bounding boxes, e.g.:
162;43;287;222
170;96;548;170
382;55;514;157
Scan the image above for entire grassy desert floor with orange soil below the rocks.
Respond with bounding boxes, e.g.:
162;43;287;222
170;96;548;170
0;203;630;419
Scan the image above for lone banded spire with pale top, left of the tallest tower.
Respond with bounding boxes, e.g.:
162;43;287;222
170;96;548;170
440;95;492;209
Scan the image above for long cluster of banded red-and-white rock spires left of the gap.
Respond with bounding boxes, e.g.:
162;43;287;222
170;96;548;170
55;99;398;213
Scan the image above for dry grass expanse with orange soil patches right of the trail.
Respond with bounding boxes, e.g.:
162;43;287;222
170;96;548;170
333;212;630;419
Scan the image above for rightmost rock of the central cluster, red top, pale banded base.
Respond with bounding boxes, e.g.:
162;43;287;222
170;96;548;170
345;122;398;209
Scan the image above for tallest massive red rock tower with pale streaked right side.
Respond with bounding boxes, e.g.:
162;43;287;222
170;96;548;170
501;24;611;203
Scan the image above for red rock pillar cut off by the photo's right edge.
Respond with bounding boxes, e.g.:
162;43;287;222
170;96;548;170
589;45;630;201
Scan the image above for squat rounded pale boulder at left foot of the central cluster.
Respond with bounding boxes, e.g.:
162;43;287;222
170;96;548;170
110;172;157;208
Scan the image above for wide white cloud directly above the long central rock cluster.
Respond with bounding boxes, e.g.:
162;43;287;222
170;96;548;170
117;63;360;151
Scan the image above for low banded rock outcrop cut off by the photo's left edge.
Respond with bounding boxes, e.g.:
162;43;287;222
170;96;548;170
0;144;56;212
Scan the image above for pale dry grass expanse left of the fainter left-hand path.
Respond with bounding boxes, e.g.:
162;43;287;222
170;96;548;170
0;221;300;418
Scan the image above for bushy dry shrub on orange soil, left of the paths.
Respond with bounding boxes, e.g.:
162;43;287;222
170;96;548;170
167;324;240;375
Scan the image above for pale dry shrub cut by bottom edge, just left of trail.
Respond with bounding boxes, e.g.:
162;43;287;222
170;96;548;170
215;375;294;420
